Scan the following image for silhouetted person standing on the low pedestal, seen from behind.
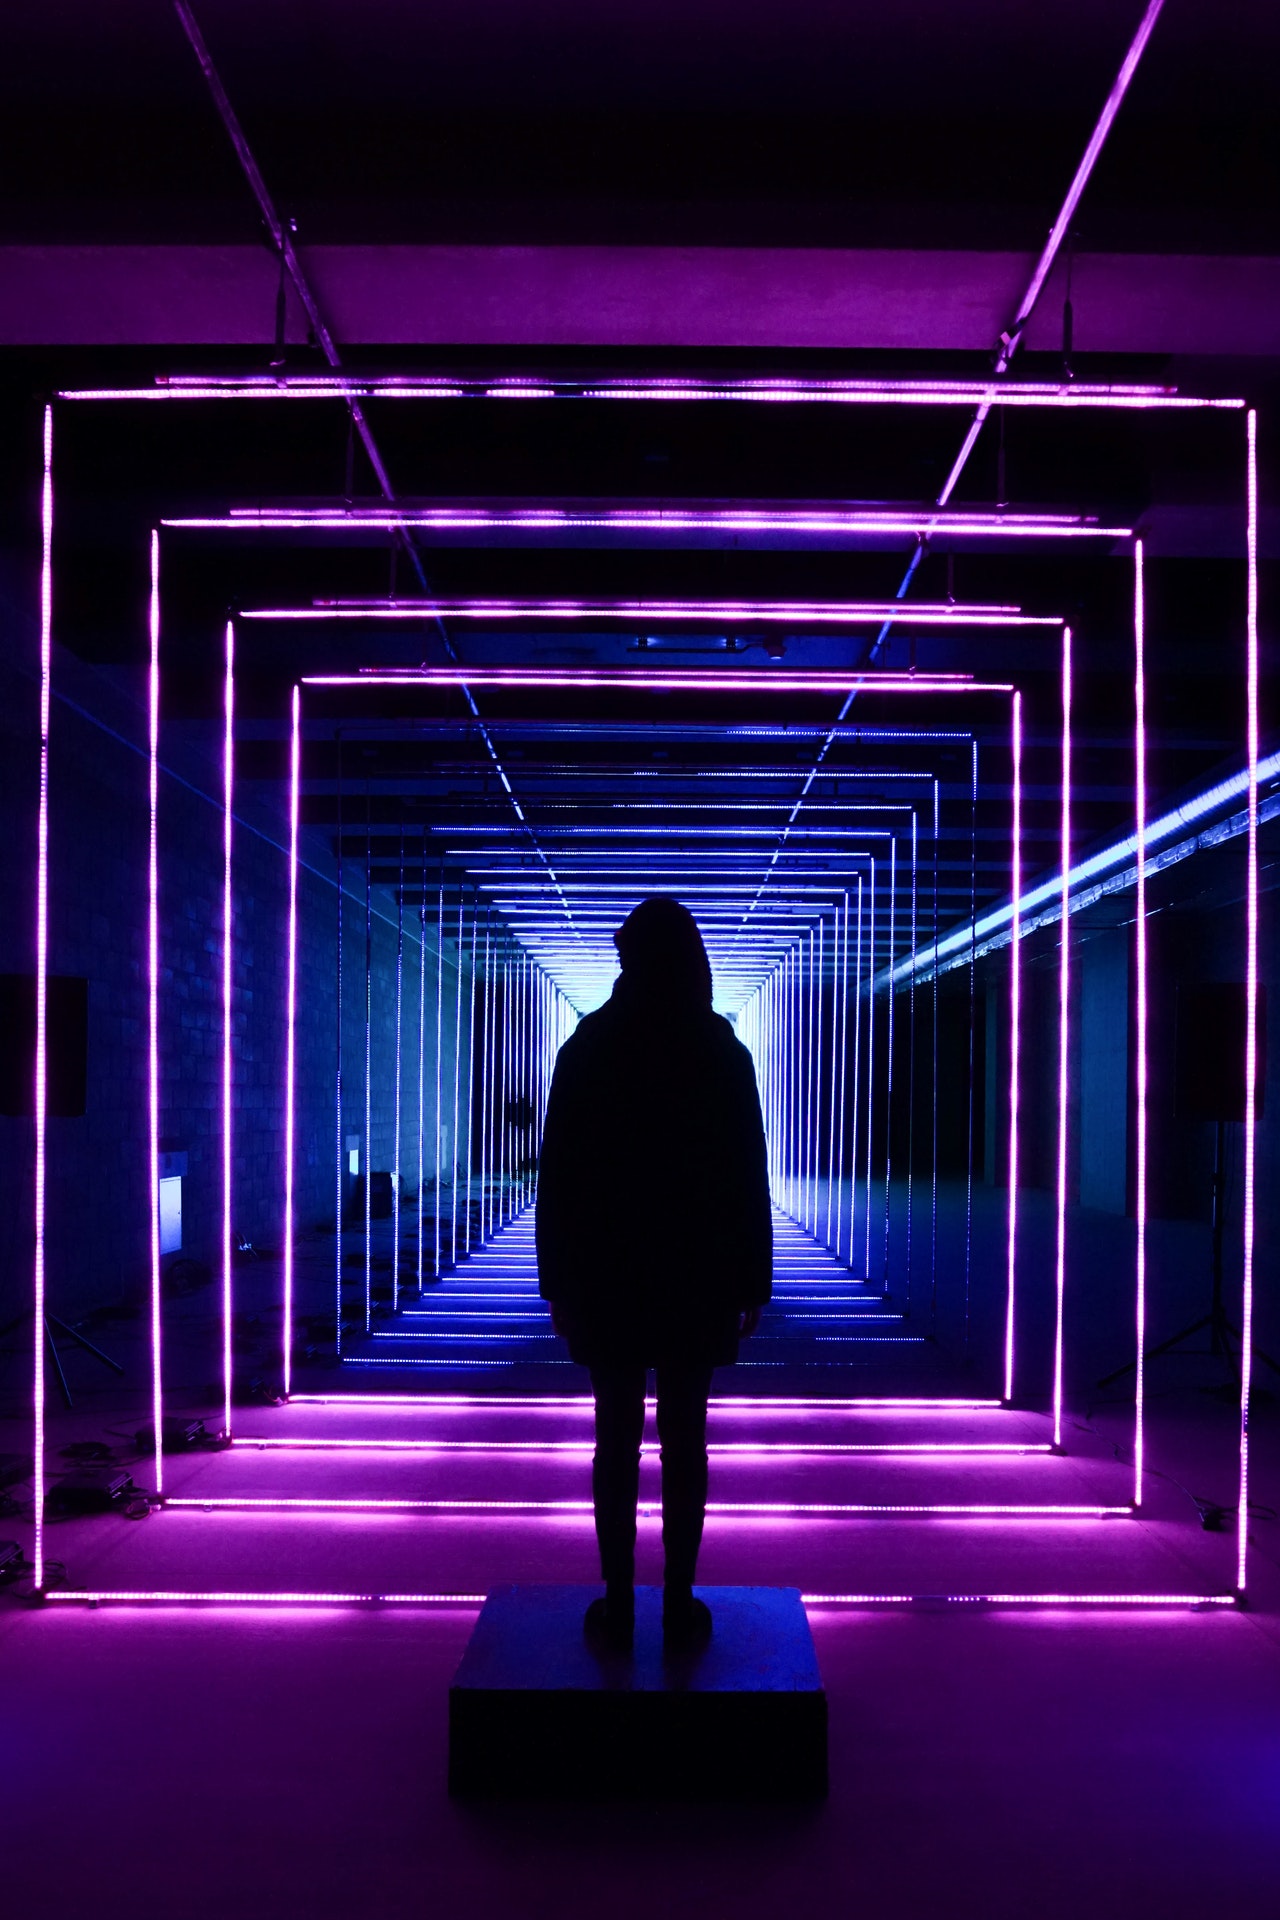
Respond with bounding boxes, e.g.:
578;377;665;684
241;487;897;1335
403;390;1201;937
537;899;773;1647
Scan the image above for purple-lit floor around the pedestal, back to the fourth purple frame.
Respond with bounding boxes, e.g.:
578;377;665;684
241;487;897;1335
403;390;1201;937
0;1190;1280;1920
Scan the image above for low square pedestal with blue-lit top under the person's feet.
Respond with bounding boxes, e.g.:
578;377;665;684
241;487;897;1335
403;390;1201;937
449;1586;827;1799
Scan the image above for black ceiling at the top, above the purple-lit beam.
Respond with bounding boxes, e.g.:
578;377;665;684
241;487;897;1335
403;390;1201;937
0;0;1280;253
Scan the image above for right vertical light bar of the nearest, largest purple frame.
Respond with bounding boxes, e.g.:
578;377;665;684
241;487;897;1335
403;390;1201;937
1236;407;1257;1594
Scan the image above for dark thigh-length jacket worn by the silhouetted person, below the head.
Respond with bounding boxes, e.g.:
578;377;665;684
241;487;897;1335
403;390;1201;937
535;972;773;1365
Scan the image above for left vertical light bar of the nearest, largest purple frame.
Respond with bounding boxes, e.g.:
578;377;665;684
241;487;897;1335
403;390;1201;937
31;407;54;1592
